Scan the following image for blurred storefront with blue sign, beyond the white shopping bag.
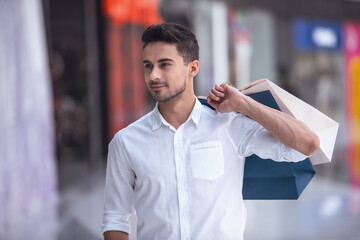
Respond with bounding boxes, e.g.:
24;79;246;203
288;18;348;182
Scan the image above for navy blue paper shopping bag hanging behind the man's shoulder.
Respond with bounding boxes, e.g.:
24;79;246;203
199;91;315;200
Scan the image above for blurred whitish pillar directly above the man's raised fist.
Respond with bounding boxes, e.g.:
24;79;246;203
191;1;230;96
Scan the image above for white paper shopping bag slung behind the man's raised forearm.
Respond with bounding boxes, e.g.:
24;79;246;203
240;79;339;165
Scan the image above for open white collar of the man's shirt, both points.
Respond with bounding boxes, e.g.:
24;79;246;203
152;98;203;131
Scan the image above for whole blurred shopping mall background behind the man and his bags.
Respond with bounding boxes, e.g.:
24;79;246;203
0;0;360;240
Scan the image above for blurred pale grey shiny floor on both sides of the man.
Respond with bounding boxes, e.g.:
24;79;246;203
59;172;360;240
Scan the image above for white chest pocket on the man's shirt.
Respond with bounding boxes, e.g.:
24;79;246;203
190;141;224;180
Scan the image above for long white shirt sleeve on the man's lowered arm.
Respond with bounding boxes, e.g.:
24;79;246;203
102;131;135;233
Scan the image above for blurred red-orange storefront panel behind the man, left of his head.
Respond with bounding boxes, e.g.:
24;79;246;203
102;0;162;140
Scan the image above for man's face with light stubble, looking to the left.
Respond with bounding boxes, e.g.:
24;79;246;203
143;42;192;102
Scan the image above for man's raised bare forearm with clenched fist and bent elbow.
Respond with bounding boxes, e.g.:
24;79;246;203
208;85;320;156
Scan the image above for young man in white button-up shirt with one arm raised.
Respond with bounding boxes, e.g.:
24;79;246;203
102;23;319;240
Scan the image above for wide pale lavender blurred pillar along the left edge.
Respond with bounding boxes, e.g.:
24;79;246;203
0;0;58;240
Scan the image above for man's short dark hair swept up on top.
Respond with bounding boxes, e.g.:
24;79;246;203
141;23;199;64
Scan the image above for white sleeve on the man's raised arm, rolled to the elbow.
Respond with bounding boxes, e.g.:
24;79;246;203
229;115;308;162
